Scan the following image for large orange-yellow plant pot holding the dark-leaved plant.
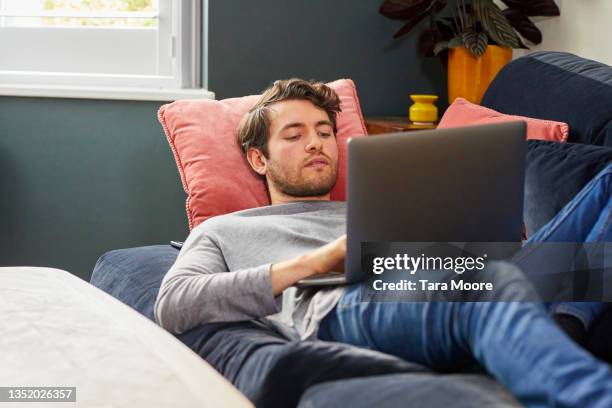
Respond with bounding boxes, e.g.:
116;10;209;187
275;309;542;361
448;45;512;104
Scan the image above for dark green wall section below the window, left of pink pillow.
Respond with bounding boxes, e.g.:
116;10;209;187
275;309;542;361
0;97;187;279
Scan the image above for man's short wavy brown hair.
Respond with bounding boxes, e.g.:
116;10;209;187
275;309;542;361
237;78;340;157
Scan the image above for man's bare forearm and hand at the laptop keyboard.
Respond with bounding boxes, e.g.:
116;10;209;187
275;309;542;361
270;235;346;296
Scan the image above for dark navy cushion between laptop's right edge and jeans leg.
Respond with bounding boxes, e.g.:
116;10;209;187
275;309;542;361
523;140;612;237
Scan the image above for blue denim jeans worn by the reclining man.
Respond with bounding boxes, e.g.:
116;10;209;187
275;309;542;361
319;166;612;407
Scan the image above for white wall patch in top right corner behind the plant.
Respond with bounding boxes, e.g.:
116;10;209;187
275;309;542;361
514;0;612;65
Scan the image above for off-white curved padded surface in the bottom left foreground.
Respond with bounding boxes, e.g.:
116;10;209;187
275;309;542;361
0;267;252;408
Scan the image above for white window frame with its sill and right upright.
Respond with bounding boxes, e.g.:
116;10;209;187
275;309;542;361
0;0;214;100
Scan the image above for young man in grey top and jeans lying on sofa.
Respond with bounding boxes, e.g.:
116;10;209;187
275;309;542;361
155;79;612;407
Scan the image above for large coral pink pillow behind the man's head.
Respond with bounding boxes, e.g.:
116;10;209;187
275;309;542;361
157;79;367;229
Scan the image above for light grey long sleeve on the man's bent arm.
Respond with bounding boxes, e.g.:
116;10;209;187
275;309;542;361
155;229;280;333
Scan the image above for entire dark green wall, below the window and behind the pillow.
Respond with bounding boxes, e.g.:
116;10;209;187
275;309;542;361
0;0;445;279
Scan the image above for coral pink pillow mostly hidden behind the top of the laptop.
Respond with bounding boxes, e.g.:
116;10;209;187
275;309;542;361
438;98;569;142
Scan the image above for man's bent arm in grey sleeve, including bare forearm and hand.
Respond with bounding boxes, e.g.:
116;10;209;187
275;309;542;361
154;226;346;333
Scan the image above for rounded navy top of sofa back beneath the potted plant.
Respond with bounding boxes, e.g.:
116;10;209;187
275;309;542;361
482;52;612;147
